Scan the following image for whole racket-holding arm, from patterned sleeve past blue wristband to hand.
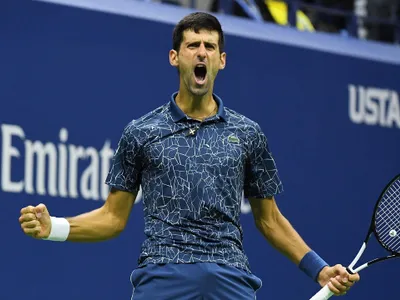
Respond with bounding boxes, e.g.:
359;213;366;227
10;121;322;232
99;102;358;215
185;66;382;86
244;124;360;295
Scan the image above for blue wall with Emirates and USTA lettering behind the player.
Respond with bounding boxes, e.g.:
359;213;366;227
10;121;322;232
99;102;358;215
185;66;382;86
0;0;400;300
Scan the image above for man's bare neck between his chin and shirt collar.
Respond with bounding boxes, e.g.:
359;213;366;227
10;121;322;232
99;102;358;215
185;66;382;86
175;84;217;120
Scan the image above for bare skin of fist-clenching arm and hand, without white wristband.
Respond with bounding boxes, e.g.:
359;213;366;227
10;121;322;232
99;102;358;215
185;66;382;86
19;189;137;242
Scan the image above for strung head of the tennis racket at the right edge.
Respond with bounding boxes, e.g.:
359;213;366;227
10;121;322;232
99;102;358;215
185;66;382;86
370;174;400;256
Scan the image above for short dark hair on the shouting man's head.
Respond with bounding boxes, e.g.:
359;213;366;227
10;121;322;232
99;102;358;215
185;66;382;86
172;12;225;53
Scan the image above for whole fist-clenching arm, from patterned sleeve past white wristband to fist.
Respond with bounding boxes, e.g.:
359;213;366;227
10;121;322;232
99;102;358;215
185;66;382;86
19;123;143;242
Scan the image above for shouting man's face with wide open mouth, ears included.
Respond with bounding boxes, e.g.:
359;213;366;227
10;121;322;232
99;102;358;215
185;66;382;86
169;30;226;96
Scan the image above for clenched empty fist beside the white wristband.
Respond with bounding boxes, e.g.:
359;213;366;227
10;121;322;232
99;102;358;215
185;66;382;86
19;204;51;239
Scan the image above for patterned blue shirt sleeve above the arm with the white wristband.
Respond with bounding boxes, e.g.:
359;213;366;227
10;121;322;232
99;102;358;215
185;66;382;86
105;126;143;193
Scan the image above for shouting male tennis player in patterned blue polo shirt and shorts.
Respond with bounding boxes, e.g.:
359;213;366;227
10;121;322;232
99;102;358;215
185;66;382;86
19;13;359;300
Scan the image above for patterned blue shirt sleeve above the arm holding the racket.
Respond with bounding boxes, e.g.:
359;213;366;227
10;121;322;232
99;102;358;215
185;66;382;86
244;126;283;198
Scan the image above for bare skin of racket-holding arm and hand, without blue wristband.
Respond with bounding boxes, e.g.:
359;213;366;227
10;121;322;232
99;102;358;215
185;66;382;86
249;197;360;295
